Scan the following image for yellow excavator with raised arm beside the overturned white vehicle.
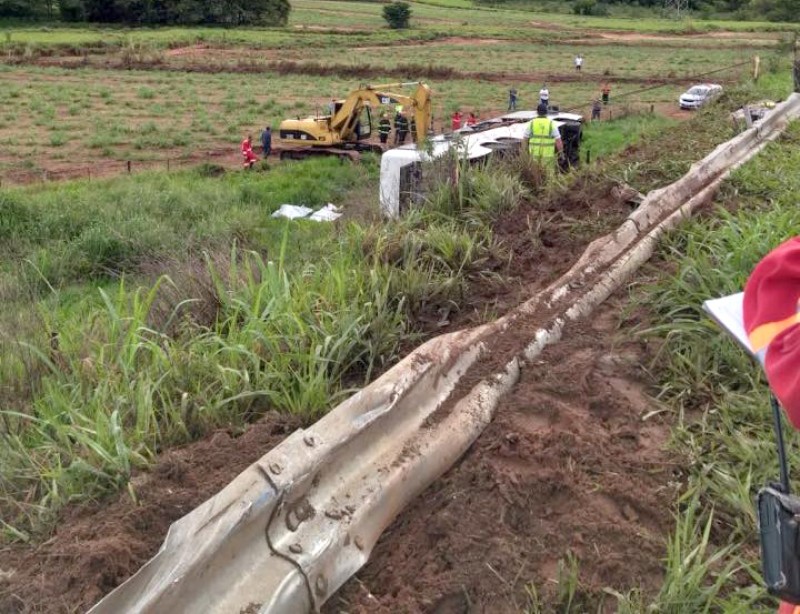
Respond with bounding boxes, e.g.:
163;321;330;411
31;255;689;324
279;81;431;159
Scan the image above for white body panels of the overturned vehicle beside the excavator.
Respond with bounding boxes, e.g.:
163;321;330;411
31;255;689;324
380;111;582;217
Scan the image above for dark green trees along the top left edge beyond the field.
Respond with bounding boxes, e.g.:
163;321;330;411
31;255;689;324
0;0;291;26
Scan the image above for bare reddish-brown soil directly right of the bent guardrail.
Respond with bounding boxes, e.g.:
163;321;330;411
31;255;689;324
326;303;675;613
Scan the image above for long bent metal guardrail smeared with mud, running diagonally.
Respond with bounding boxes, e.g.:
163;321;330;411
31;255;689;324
90;94;800;614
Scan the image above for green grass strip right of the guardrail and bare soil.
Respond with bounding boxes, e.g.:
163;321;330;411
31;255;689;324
628;123;800;613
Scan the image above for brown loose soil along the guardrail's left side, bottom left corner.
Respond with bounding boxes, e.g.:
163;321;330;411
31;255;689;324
0;414;300;614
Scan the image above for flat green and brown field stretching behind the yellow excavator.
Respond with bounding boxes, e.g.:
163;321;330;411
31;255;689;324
0;0;783;183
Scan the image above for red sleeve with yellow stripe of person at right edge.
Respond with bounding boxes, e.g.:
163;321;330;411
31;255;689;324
743;237;800;614
